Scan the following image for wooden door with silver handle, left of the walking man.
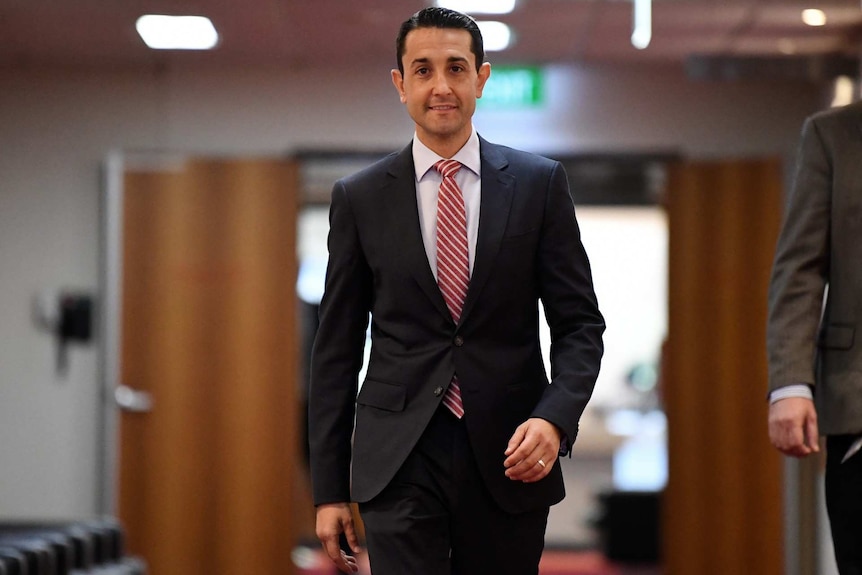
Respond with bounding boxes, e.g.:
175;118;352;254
117;159;301;575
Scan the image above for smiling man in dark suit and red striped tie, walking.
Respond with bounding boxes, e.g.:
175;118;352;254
309;8;604;575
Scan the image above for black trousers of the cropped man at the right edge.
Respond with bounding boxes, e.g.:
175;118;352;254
826;435;862;575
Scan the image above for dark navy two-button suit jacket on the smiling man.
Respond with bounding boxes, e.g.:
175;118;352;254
309;139;604;512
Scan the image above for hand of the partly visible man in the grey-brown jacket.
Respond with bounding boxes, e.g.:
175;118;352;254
769;397;820;457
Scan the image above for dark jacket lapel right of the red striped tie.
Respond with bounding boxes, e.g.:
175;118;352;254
462;138;515;323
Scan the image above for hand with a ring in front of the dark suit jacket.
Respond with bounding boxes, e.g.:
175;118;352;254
503;417;563;483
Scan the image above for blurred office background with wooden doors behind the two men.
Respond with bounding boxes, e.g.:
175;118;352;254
0;0;862;575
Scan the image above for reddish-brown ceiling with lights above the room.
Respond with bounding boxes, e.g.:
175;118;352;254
0;0;862;73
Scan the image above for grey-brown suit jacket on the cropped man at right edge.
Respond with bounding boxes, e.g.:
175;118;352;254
767;103;862;435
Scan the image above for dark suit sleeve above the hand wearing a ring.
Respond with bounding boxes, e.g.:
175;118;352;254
533;163;605;453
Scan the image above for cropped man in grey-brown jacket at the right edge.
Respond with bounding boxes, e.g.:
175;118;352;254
767;103;862;575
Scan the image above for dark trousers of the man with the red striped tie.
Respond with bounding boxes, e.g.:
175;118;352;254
359;407;548;575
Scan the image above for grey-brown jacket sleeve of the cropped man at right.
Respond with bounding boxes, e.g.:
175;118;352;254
766;118;832;391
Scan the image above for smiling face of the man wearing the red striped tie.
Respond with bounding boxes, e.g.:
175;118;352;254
392;28;491;157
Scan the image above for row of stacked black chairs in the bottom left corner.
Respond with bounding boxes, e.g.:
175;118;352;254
0;519;147;575
